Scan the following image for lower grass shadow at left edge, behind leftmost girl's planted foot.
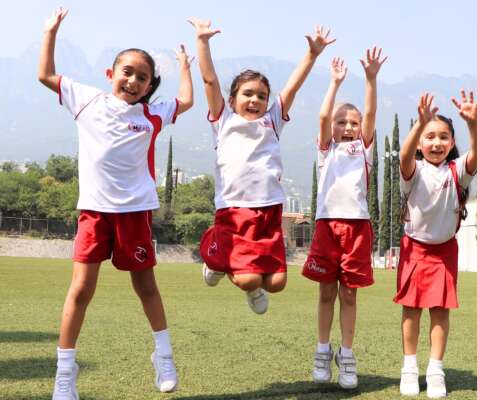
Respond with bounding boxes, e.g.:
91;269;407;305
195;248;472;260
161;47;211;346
0;357;95;382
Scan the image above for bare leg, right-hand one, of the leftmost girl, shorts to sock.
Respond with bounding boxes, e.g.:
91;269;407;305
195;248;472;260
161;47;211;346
131;268;167;332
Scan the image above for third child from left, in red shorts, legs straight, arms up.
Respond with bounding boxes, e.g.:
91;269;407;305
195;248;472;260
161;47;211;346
303;47;387;389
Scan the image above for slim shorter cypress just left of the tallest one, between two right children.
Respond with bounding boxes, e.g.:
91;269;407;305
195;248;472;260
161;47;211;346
379;136;391;255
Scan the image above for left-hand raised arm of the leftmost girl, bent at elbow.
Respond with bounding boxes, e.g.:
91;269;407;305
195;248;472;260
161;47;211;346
38;8;68;93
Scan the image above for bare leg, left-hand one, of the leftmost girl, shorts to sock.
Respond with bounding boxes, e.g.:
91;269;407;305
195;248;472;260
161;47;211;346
58;262;100;349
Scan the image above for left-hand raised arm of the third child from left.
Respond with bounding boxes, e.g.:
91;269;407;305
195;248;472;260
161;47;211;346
318;57;348;149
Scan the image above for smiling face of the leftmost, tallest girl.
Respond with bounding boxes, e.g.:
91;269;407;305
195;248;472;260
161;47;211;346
106;51;153;104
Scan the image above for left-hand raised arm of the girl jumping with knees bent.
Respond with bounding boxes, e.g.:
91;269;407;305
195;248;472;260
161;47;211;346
187;17;224;119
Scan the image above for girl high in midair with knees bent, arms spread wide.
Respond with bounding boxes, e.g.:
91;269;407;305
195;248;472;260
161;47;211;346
189;18;334;314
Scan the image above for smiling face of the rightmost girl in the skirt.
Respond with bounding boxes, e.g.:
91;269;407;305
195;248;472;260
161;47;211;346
418;119;455;165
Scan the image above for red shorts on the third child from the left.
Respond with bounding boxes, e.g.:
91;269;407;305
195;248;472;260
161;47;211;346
302;219;374;288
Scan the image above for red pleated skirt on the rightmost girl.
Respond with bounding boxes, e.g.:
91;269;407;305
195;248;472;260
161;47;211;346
394;236;459;308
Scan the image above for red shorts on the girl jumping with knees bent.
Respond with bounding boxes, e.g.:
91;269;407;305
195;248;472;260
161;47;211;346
200;204;287;275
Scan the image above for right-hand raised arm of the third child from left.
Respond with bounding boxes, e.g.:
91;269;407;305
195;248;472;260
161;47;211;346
360;46;387;145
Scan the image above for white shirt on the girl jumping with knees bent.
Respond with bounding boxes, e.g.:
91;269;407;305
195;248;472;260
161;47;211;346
209;97;289;209
